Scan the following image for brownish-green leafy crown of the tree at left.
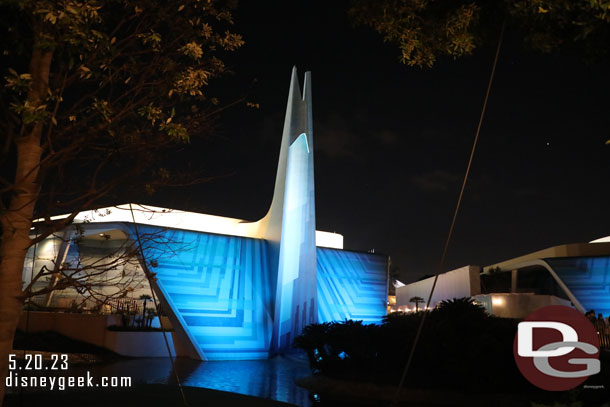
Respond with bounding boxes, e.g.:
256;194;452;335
0;0;244;209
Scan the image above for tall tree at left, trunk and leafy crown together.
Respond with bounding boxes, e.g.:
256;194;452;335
0;0;243;399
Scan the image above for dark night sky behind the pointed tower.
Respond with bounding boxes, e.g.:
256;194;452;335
154;1;610;281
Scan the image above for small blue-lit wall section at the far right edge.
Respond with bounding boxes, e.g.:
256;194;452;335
544;256;610;316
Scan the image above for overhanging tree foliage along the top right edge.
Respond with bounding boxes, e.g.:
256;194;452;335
349;0;610;67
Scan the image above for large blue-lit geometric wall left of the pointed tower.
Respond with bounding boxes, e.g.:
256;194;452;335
138;226;274;360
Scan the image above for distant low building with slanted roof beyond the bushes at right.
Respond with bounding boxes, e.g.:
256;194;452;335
392;238;610;318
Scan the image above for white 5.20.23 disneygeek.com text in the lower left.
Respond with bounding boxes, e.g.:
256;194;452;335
5;354;131;390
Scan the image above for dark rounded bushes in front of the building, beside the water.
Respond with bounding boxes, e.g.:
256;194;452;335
294;298;527;391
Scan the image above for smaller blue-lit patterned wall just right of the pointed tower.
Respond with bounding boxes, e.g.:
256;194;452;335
317;247;388;324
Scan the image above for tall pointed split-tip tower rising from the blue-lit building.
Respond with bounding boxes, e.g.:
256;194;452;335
258;67;318;351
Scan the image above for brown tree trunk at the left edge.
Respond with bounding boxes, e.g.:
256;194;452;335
0;44;53;405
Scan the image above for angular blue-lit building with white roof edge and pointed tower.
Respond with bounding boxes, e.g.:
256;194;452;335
24;68;388;360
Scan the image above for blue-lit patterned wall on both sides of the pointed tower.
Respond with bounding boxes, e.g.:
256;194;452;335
125;224;387;360
